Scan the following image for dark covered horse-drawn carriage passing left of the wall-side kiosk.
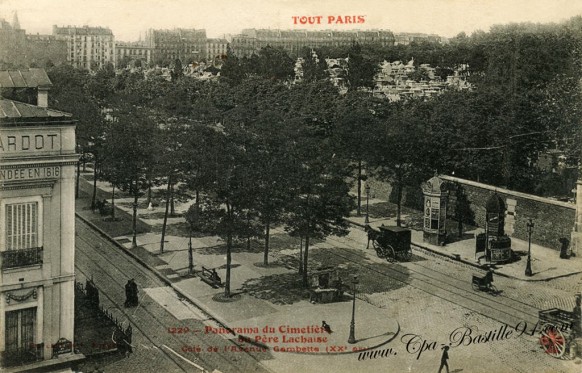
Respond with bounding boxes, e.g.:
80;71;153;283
366;225;412;261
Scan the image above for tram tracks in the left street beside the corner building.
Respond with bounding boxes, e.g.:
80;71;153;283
76;220;272;372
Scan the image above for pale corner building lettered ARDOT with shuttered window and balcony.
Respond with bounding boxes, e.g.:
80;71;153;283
0;69;83;372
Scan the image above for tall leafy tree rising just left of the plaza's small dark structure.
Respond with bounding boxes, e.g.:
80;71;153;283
285;108;355;287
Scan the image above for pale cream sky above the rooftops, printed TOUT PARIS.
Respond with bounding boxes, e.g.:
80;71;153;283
0;0;582;41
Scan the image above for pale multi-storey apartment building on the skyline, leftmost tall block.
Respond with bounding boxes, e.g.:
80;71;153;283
53;26;115;71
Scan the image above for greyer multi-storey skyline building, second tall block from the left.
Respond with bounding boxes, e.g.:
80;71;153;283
145;28;206;65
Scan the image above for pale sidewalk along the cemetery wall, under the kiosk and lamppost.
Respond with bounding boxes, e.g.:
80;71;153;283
348;199;582;281
